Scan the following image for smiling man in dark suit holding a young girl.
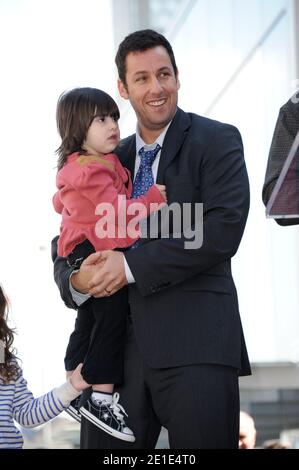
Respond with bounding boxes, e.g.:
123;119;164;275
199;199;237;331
53;30;250;449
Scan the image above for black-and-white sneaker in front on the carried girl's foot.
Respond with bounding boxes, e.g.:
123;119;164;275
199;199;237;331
80;393;135;442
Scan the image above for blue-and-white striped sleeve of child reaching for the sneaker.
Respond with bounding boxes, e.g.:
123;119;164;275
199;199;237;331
13;374;80;428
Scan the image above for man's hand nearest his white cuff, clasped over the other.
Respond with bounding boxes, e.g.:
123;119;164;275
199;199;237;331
88;250;128;298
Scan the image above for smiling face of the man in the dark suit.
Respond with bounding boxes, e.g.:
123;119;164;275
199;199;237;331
118;46;180;138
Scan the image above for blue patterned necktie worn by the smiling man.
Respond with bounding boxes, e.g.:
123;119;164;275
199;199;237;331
129;144;161;250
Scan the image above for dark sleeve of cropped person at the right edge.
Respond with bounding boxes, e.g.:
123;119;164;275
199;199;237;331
262;101;299;226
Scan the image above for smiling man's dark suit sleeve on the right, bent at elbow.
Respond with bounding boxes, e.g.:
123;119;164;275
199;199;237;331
125;125;249;295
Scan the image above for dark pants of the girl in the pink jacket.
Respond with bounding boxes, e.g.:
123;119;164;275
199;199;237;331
64;240;129;384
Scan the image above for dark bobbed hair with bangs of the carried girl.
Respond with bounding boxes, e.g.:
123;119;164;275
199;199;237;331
56;88;119;170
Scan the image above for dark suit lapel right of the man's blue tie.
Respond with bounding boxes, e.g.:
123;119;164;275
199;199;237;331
157;108;191;182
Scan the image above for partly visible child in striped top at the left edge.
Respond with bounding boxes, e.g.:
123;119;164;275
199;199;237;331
0;286;86;449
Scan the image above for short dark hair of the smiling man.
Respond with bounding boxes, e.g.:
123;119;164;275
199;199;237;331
115;29;178;86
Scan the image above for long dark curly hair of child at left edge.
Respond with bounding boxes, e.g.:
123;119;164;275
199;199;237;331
0;286;18;383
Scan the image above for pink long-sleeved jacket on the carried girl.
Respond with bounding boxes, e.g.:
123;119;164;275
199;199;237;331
53;153;165;257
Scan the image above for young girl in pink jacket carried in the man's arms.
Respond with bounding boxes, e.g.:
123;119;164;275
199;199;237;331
53;88;165;442
